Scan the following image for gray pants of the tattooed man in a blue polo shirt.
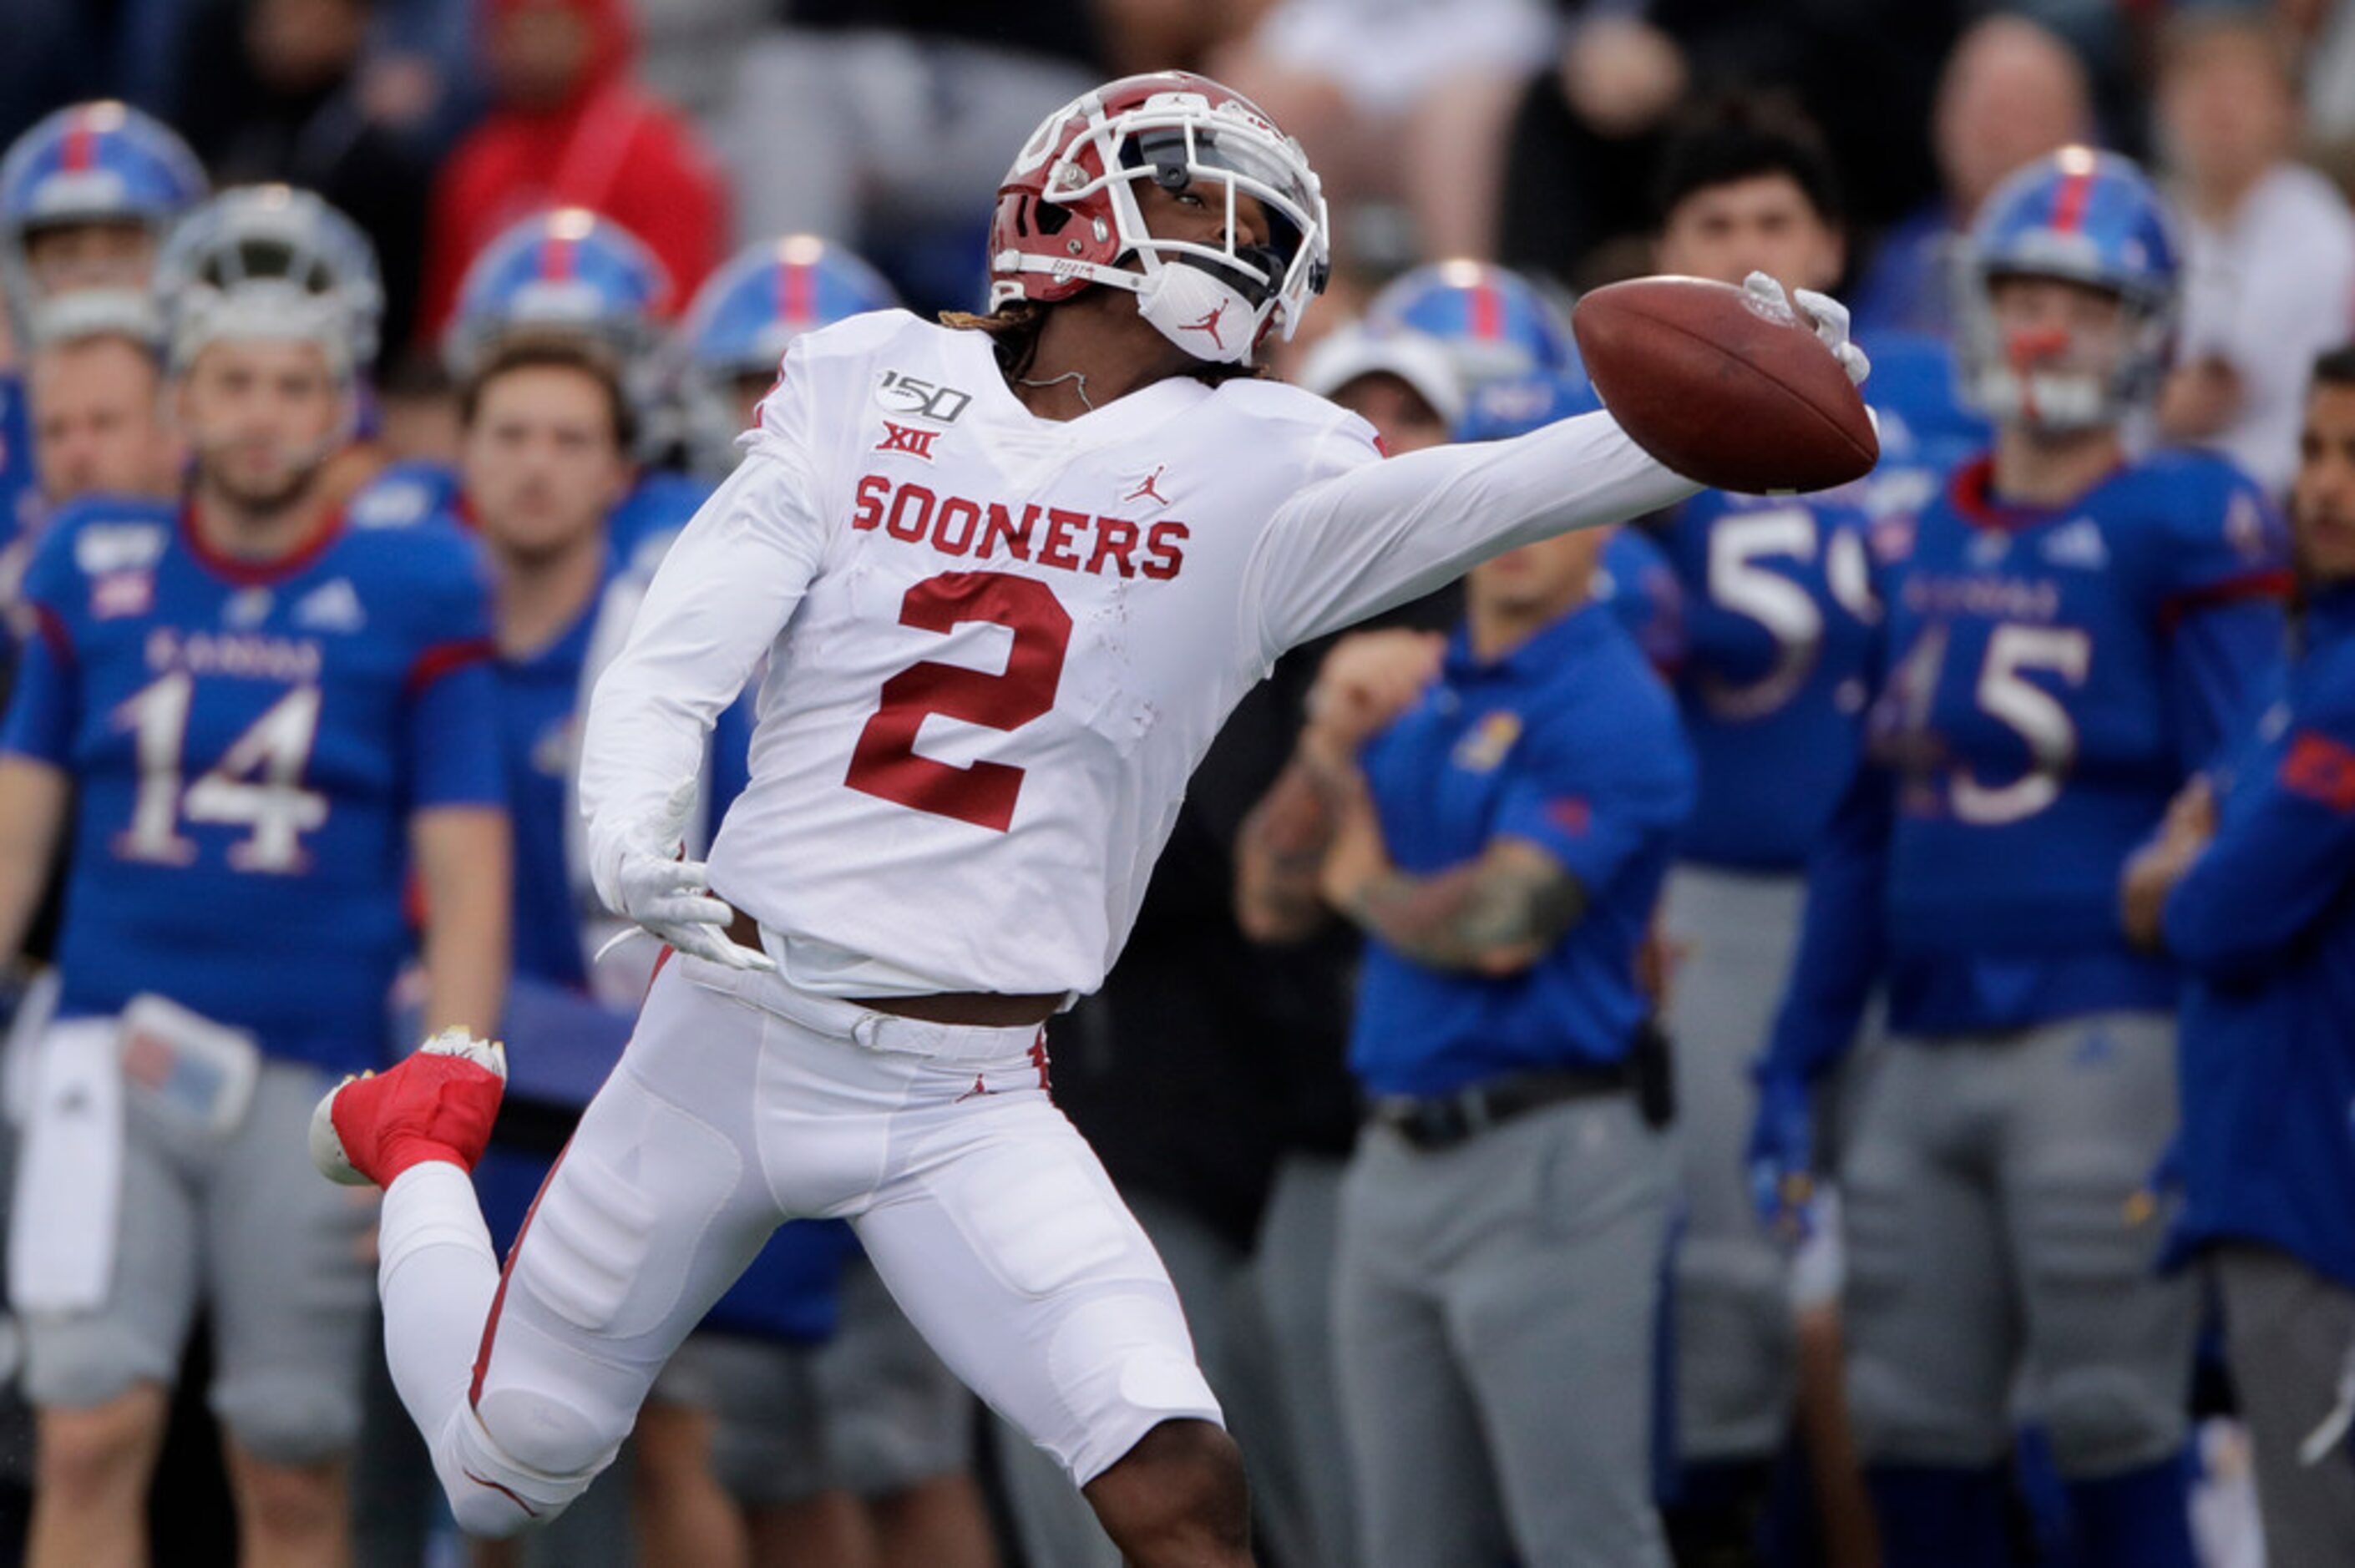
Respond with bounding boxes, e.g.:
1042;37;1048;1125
1333;1095;1674;1568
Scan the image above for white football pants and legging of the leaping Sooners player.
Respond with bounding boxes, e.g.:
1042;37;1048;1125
377;959;1220;1535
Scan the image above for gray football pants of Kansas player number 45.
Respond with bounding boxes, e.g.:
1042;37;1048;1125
1841;1013;2197;1481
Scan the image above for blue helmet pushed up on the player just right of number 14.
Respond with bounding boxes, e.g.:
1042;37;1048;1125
443;207;671;382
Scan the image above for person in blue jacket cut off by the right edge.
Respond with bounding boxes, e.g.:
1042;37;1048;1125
2125;348;2355;1568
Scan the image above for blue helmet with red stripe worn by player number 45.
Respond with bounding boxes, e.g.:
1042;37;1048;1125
1955;146;2183;431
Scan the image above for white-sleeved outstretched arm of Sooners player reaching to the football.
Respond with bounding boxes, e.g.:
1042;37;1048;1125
1246;414;1700;657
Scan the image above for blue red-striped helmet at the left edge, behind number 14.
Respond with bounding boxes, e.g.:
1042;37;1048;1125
0;101;205;341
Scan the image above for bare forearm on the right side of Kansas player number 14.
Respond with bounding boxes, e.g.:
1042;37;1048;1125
410;805;511;1040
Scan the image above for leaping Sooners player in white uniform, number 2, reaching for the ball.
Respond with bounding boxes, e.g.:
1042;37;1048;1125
313;73;1853;1563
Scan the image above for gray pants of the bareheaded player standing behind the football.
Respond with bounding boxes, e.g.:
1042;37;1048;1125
1660;864;1806;1462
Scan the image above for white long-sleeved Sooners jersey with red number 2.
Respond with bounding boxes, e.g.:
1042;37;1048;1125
582;311;1694;996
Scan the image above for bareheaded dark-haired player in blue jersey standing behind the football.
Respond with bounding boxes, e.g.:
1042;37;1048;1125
1629;101;1879;1549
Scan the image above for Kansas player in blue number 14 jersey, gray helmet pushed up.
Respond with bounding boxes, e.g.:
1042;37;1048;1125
0;186;506;1565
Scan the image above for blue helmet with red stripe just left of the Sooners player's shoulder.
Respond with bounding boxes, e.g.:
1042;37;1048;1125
678;233;899;471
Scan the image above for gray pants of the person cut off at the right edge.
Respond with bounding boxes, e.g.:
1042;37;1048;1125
2209;1246;2355;1568
